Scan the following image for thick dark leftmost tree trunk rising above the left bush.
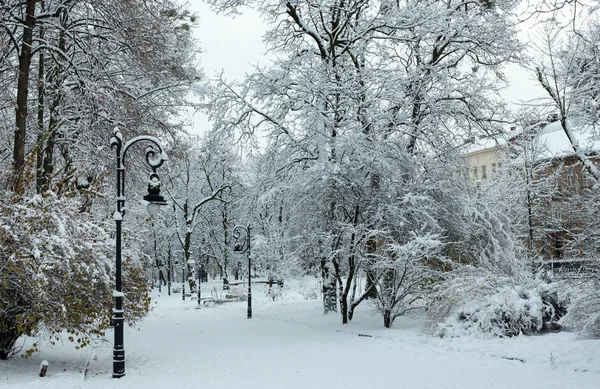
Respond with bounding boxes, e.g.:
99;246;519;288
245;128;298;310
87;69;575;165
13;0;37;193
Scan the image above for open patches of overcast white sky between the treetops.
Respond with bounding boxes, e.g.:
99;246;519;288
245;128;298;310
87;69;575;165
190;0;543;134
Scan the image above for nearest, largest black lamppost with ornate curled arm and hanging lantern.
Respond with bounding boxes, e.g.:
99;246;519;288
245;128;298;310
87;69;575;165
110;128;167;378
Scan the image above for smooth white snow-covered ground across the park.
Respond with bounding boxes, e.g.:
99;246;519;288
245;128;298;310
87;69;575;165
0;282;600;389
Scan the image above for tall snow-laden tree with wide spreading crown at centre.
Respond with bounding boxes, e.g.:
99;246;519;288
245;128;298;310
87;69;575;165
208;0;519;322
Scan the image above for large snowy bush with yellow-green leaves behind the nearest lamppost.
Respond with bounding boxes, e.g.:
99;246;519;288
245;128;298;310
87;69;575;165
0;193;149;359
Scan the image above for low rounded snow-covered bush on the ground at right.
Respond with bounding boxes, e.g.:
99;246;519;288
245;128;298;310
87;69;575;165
427;268;565;337
